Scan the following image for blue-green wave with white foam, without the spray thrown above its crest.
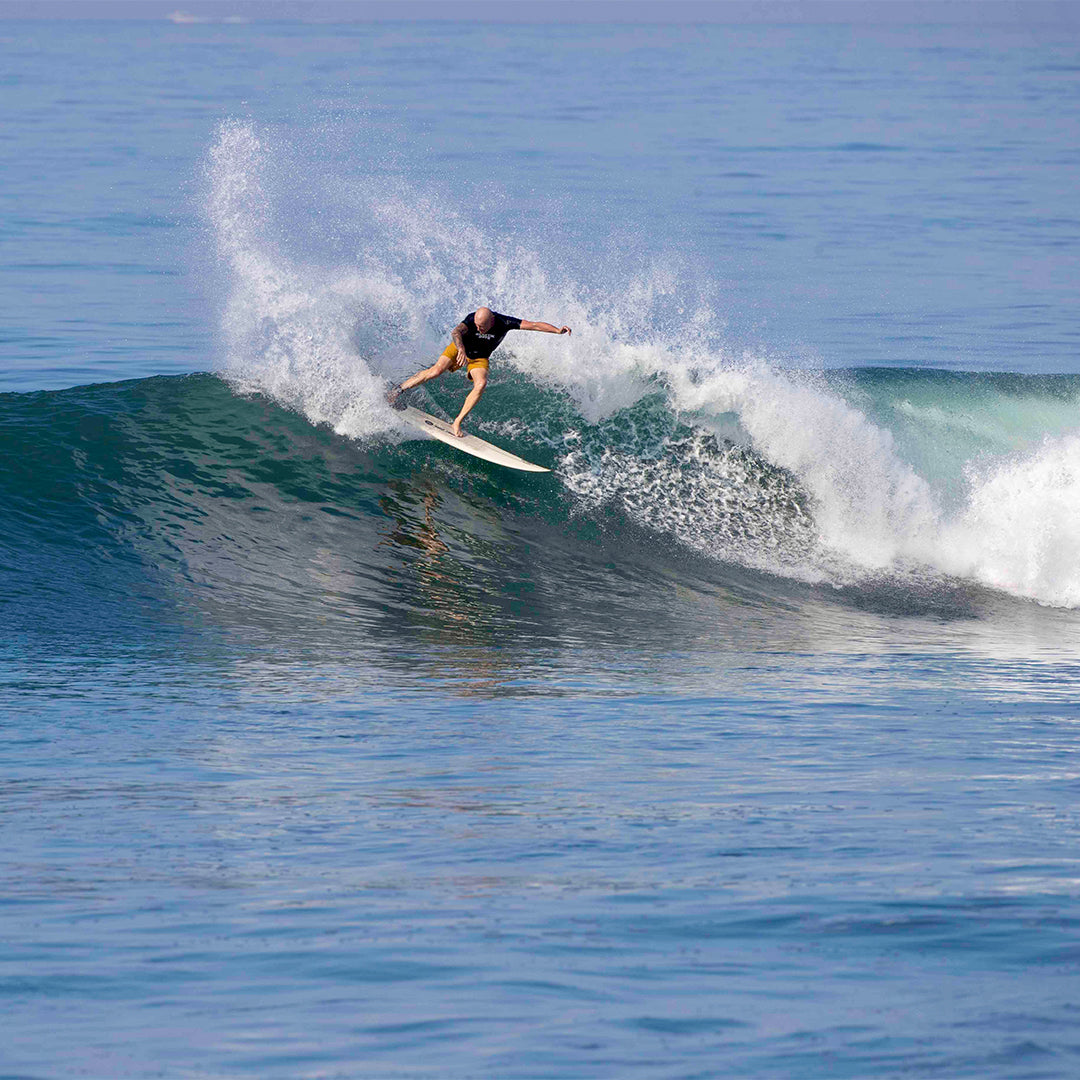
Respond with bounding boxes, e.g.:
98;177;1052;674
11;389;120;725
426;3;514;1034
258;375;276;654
0;367;1080;656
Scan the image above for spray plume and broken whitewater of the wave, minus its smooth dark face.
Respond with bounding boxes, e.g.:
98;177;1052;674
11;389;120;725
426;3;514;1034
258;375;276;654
172;122;1080;608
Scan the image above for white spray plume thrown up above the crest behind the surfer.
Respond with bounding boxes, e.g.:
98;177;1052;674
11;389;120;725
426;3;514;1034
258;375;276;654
207;121;713;437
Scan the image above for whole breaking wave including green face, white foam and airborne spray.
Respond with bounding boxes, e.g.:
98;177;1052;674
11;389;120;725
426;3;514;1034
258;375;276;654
0;123;1080;656
